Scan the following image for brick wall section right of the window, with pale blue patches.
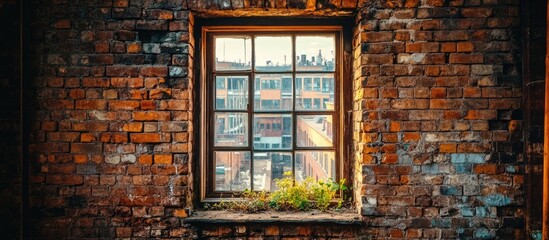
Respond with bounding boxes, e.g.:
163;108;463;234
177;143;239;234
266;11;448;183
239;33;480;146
354;0;526;239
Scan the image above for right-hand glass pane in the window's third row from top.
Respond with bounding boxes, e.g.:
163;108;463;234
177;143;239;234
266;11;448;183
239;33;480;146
296;115;334;147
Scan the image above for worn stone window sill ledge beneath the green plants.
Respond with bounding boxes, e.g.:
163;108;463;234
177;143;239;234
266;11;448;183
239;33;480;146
183;211;363;225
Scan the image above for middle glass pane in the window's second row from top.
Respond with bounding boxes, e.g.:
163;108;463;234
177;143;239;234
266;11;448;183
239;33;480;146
254;74;293;111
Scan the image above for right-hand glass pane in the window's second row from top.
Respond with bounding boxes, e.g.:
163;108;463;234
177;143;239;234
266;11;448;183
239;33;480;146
295;73;335;111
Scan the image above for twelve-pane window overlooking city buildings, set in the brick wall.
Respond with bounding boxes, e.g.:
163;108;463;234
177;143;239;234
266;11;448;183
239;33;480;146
201;26;343;200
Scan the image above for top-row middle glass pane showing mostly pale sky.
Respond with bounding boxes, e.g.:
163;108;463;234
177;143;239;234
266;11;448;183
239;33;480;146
255;36;292;72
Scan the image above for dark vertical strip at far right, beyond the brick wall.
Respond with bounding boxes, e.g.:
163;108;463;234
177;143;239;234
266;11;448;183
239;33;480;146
522;0;547;239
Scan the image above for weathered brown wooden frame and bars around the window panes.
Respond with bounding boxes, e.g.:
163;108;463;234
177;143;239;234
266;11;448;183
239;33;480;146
195;19;353;203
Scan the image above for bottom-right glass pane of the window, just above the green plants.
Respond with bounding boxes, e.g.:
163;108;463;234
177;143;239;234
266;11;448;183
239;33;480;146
295;151;336;181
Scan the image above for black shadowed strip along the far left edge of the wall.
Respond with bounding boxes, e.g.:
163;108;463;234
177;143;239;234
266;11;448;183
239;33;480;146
0;1;22;239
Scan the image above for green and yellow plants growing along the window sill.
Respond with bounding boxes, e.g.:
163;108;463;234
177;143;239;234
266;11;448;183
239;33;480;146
205;172;347;212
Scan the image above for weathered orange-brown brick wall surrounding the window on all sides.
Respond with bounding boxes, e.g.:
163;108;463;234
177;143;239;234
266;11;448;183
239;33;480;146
22;0;540;239
